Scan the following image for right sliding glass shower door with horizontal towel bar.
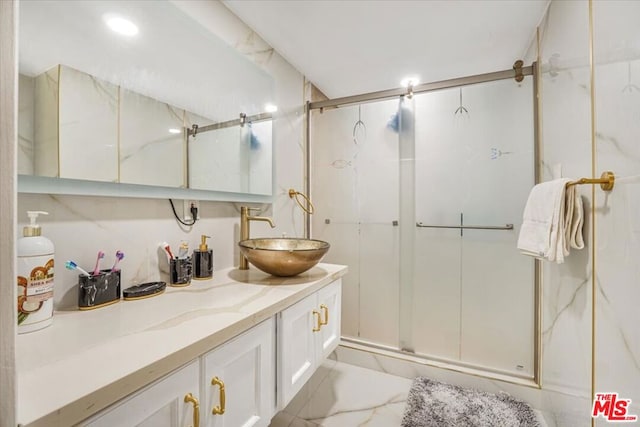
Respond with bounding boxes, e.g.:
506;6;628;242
412;78;535;377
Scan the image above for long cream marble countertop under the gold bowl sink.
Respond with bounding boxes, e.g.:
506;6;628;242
16;264;347;426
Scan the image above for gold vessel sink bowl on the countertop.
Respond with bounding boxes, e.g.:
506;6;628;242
238;237;330;277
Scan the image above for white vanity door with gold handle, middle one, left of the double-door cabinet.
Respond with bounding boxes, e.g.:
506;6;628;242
201;318;276;427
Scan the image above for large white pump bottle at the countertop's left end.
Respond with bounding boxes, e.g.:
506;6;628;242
17;211;54;334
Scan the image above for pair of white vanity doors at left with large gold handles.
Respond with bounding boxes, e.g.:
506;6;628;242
83;317;276;427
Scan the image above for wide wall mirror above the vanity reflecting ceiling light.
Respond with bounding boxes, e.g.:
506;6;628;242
18;0;274;200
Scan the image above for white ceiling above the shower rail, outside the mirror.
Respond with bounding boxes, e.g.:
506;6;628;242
223;0;549;98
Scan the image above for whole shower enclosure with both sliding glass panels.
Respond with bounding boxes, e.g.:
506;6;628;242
309;67;538;379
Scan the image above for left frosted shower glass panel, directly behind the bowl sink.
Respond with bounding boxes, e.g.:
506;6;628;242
311;100;400;348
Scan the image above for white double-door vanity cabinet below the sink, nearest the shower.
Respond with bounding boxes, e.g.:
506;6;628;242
278;280;342;409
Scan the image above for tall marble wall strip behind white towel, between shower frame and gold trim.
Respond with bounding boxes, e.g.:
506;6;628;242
540;37;591;408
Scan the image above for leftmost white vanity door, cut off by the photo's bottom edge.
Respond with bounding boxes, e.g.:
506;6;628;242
80;360;200;427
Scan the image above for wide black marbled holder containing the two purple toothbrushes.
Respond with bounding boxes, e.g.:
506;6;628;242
78;270;120;310
